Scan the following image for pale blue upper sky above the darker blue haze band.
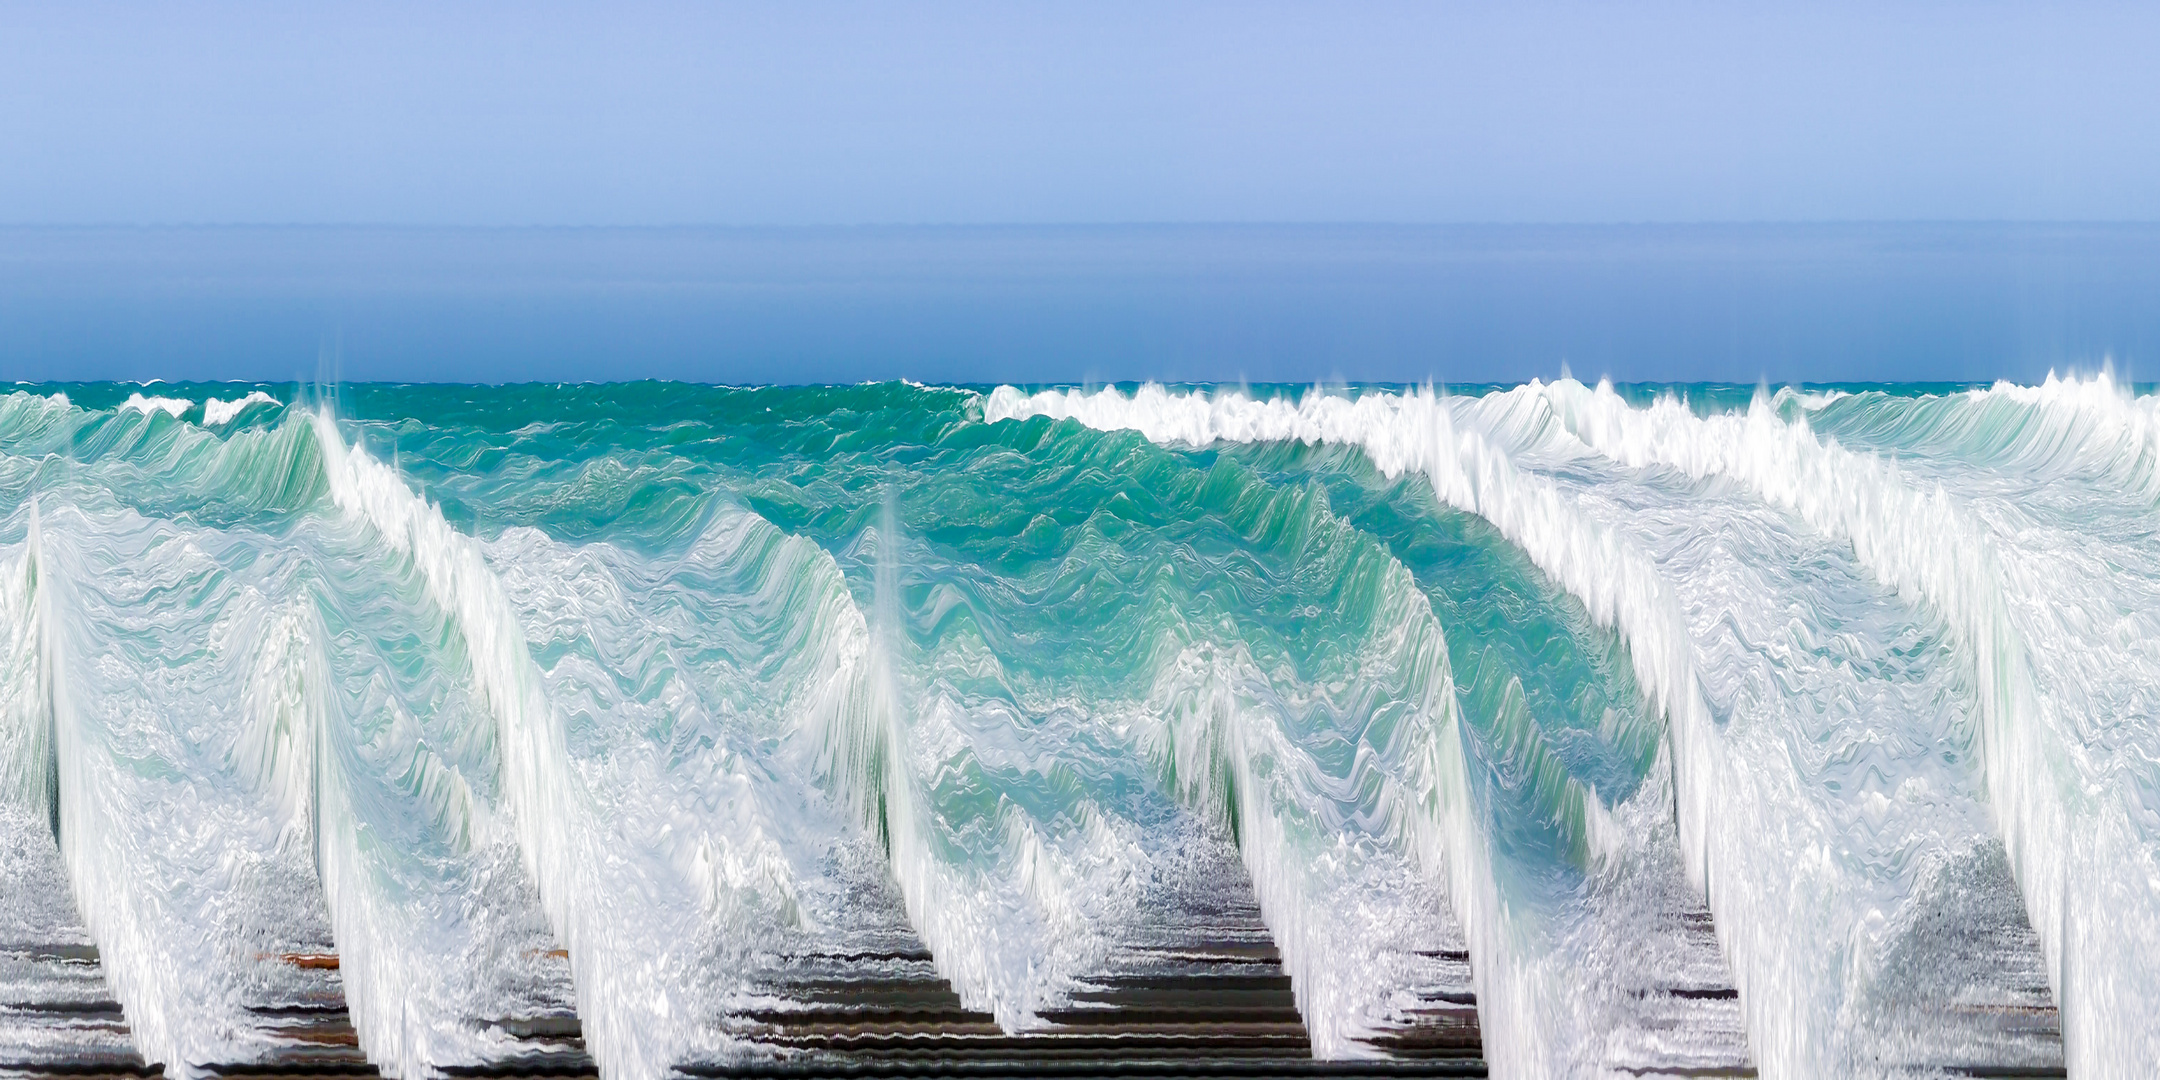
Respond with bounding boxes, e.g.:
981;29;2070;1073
12;0;2160;225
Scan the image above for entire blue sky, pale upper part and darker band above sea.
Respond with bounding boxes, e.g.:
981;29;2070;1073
0;0;2160;382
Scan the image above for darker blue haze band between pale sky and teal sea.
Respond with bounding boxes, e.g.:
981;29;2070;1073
0;225;2160;382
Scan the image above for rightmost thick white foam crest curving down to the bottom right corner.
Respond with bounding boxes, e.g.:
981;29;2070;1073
1542;376;2160;1076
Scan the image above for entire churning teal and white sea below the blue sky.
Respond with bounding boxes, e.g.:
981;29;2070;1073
0;376;2160;1078
